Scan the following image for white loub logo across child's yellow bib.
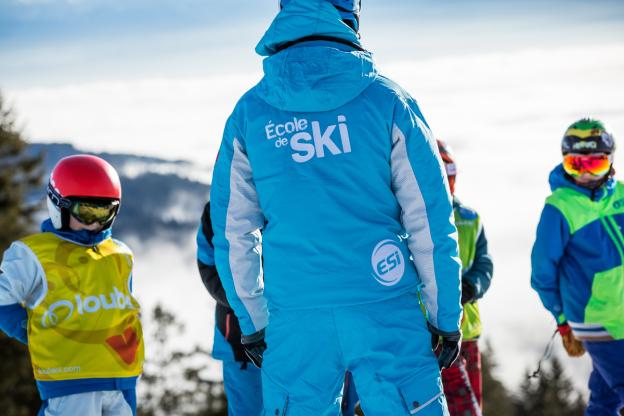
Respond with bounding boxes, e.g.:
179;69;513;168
41;287;134;328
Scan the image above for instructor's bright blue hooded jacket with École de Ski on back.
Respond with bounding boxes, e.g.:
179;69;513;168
211;0;462;335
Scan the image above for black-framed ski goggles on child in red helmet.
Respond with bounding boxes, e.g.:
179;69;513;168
48;185;119;225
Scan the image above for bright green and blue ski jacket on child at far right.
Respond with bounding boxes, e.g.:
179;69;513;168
531;165;624;341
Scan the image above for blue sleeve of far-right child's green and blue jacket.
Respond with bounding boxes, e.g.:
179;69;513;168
531;204;570;324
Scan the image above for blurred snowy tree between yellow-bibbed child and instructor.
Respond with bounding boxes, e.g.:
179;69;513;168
138;306;227;416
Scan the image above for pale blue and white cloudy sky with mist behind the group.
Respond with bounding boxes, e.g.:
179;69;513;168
0;0;624;393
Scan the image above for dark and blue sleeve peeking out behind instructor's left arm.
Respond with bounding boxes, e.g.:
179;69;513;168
197;203;230;308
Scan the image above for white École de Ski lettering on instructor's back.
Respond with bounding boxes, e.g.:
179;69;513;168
264;115;351;163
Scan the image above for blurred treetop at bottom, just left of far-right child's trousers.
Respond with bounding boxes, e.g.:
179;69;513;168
516;357;585;416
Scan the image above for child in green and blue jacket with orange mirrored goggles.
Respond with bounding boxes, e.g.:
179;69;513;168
531;118;624;416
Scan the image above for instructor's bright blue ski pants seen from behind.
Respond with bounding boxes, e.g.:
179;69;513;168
262;293;448;416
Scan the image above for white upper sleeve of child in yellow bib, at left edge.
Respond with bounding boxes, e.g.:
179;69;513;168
0;241;47;308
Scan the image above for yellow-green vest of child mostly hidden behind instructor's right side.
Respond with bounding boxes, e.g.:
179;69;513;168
454;208;482;341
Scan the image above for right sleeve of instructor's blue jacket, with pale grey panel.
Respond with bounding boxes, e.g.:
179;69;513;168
390;99;462;332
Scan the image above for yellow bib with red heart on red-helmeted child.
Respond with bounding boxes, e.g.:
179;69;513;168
22;233;144;381
